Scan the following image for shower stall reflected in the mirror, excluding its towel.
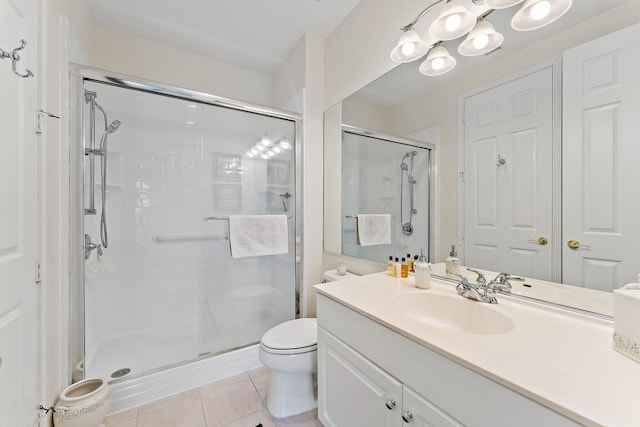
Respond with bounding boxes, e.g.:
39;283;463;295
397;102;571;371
341;126;434;263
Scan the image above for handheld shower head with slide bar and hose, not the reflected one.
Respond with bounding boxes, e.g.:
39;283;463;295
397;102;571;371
85;90;122;252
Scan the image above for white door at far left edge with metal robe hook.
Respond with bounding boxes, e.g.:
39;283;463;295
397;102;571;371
0;0;38;427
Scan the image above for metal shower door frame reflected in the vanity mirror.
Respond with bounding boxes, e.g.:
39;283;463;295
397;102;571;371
340;124;438;263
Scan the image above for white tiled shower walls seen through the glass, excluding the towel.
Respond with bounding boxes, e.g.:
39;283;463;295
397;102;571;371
85;84;295;382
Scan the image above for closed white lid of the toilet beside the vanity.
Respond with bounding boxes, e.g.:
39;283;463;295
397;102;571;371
262;319;318;350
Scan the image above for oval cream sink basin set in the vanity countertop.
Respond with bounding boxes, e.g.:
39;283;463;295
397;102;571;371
393;292;513;335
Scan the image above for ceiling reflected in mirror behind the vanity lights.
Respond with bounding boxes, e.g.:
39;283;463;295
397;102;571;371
350;0;627;108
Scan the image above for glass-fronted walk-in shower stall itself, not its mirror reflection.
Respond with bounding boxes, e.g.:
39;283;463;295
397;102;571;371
71;67;300;392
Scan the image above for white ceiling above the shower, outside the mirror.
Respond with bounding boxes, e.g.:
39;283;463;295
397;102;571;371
89;0;359;74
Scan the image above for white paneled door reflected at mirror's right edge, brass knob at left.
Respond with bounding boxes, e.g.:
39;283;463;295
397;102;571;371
562;25;640;291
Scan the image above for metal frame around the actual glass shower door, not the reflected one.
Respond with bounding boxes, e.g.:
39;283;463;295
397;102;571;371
68;63;305;382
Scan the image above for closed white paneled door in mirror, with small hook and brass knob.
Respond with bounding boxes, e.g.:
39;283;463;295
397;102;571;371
461;66;557;280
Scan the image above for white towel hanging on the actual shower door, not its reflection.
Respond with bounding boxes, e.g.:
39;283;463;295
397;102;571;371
229;215;289;258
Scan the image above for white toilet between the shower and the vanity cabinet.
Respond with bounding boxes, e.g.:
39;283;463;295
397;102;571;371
259;270;354;418
